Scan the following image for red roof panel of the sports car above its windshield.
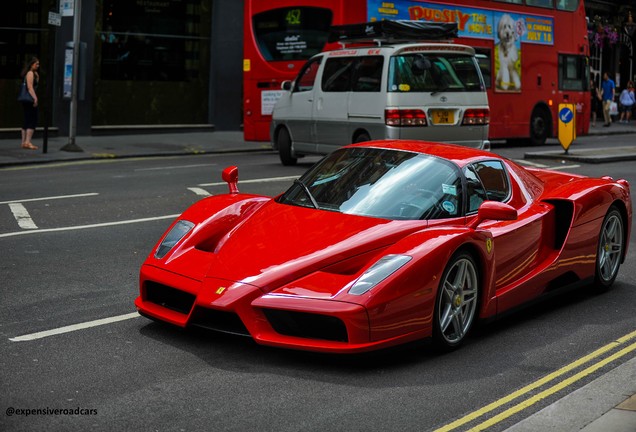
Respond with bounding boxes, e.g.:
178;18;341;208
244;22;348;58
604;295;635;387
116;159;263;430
347;140;502;168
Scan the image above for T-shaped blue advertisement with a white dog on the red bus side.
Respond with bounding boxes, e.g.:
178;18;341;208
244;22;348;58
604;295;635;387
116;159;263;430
367;0;554;92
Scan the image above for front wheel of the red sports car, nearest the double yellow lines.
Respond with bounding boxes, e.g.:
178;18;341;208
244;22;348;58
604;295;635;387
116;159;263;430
433;252;480;351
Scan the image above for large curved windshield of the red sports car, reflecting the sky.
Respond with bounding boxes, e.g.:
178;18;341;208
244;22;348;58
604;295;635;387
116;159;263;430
279;148;461;220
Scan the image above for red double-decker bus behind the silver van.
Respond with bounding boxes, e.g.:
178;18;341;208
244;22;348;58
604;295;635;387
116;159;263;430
243;0;590;144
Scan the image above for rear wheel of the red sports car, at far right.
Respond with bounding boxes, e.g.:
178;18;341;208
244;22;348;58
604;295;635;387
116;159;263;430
594;206;625;291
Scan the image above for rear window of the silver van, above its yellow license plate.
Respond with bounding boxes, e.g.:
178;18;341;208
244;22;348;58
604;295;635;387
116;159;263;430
388;53;485;93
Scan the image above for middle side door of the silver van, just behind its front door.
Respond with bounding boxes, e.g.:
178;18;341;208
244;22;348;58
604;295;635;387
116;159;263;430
314;57;356;153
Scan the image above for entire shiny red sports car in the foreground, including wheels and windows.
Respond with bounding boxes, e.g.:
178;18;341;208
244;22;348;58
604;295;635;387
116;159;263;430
135;141;632;353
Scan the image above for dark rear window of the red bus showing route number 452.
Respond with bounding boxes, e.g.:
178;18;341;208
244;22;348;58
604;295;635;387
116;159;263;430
252;7;332;61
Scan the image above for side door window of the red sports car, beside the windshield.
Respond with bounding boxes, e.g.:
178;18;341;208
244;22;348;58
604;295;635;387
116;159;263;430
464;161;510;213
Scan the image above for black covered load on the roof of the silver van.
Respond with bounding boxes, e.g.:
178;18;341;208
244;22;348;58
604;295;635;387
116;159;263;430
328;20;458;45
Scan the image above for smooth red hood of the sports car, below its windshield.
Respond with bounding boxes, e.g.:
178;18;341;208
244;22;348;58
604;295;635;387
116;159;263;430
201;201;426;291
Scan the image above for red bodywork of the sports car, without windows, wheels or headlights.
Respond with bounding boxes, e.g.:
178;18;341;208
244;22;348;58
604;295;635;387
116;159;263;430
135;141;632;353
